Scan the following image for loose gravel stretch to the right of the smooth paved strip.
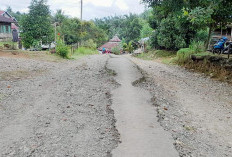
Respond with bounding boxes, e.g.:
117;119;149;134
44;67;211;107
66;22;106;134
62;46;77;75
129;57;232;157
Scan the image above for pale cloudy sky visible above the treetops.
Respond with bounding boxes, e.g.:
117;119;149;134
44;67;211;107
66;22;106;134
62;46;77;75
0;0;144;20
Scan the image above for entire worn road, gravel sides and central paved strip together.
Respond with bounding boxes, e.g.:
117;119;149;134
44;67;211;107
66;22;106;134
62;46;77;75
0;55;232;157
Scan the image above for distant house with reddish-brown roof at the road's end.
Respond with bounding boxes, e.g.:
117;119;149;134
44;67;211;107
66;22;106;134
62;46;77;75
98;36;121;52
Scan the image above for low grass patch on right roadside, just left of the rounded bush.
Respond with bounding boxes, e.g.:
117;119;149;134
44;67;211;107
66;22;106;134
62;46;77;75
136;50;176;64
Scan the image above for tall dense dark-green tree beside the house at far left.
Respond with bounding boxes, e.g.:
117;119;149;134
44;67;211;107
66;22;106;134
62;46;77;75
20;0;53;48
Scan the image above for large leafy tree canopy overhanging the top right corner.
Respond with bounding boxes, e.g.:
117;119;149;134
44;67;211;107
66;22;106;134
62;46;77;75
143;0;232;46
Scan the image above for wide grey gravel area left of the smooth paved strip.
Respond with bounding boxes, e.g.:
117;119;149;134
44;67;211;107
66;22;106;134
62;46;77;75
0;55;118;157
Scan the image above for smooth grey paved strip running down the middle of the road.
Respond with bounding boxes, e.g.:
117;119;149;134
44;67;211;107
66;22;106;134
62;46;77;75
108;55;178;157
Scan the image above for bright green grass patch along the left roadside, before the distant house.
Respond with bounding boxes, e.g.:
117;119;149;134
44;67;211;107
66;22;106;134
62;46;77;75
71;47;99;59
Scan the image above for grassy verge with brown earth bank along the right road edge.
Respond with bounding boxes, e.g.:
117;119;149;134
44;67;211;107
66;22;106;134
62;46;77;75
136;48;232;83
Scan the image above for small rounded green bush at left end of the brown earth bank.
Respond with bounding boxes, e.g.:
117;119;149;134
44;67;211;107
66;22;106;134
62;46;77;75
175;48;195;64
